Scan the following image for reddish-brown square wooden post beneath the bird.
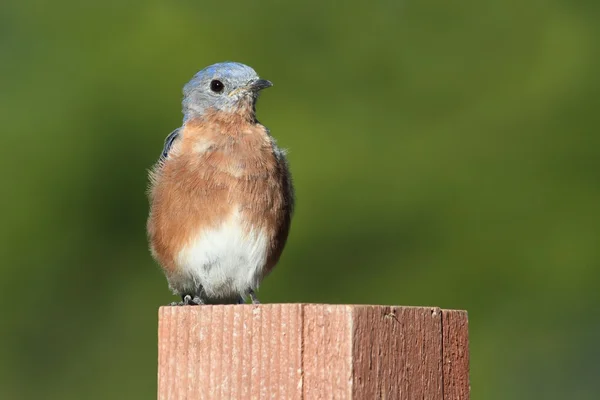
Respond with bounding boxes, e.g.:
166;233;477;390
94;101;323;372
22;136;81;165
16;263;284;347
158;304;469;400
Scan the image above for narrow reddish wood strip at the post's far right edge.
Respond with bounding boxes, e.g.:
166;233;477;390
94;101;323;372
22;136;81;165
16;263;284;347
442;310;471;400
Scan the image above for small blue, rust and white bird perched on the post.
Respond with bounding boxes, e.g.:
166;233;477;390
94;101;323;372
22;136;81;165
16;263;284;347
146;62;295;305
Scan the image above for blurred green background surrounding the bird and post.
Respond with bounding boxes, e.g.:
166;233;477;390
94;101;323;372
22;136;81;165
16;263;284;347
0;0;600;400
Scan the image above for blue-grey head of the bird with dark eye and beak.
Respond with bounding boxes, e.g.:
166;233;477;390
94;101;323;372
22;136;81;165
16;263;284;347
183;62;273;120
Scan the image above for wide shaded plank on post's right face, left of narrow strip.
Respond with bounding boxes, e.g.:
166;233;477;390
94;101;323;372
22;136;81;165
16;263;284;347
353;306;443;400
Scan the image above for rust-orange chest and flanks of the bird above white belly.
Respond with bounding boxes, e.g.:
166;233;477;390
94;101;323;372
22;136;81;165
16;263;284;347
148;112;293;272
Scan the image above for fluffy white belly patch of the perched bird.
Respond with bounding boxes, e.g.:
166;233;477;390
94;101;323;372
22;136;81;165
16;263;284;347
177;209;269;298
